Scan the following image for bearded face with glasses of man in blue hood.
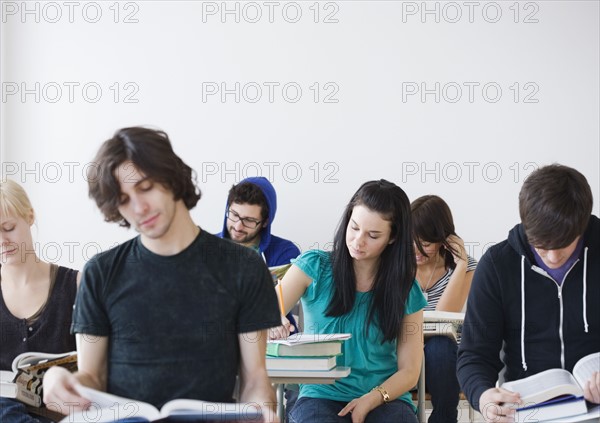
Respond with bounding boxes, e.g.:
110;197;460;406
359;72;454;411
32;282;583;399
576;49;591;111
227;203;267;245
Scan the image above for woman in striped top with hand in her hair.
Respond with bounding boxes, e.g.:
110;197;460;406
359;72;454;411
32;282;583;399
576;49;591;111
411;195;477;423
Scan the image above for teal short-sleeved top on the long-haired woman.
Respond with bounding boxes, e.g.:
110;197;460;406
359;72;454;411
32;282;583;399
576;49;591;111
292;250;427;410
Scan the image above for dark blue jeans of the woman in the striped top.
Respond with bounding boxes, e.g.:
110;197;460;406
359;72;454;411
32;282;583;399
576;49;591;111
425;336;460;423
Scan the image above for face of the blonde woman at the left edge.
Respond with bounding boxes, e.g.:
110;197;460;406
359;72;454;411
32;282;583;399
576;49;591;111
0;212;35;265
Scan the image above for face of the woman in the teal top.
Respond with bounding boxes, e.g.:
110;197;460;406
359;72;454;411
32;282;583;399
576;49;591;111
346;205;394;261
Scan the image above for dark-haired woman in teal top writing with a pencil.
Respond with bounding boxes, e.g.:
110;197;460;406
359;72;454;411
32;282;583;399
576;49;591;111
271;180;427;423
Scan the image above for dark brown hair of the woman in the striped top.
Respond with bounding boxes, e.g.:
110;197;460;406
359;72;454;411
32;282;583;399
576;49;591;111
410;195;459;269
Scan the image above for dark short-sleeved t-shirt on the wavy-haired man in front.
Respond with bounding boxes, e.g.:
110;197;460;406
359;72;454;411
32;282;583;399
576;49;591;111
72;231;281;407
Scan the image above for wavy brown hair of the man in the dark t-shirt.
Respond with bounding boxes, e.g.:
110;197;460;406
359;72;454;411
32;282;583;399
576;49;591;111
87;127;201;228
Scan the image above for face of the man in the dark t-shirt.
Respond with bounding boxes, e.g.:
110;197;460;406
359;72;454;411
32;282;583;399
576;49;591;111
115;161;176;240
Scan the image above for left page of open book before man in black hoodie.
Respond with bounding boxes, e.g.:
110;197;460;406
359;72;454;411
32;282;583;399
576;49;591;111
502;369;583;404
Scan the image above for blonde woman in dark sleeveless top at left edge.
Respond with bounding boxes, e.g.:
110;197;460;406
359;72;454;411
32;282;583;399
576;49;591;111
0;179;79;423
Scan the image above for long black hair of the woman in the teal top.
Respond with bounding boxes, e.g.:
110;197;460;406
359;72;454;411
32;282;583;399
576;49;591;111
326;179;416;343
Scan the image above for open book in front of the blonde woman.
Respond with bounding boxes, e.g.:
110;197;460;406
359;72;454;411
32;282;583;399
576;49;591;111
1;351;77;407
